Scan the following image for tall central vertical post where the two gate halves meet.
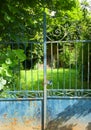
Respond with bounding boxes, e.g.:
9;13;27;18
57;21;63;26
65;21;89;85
43;4;47;129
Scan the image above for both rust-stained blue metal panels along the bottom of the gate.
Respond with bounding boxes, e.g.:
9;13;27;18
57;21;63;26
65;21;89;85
0;99;91;130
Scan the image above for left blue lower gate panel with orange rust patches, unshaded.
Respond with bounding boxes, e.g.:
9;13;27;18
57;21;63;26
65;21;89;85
0;101;42;130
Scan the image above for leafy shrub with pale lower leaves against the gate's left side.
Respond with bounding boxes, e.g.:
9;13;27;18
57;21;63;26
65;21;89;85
0;47;26;90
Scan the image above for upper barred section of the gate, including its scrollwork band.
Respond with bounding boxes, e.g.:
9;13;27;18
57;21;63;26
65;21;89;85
0;40;91;98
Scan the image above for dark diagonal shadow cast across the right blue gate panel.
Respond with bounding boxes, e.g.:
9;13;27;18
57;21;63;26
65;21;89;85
46;99;91;130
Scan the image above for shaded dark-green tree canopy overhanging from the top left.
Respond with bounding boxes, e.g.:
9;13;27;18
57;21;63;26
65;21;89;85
0;0;79;41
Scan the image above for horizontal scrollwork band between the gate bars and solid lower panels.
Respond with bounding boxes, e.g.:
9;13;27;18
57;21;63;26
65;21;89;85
2;89;91;99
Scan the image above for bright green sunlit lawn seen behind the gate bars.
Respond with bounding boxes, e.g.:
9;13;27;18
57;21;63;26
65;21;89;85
17;68;88;90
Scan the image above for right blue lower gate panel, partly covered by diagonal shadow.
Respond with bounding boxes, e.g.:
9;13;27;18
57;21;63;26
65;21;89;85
46;99;91;130
